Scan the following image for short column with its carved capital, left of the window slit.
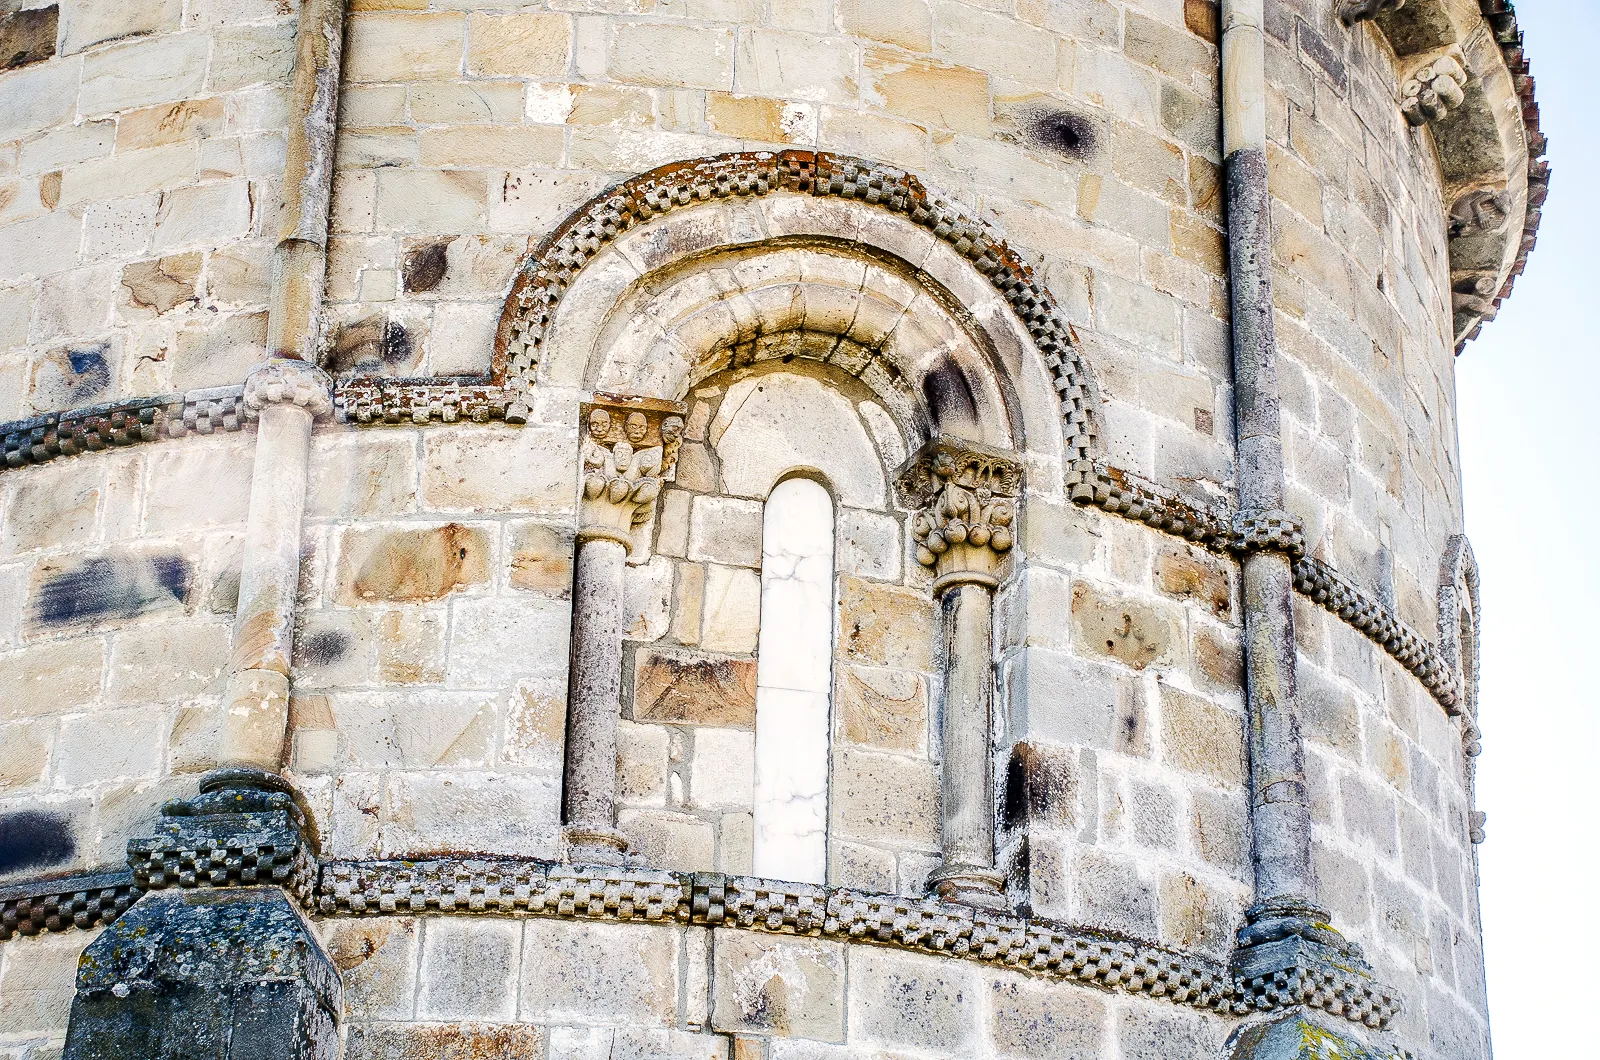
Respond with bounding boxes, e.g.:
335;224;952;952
562;394;685;865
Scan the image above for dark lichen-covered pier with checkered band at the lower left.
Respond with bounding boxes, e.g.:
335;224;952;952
62;788;341;1060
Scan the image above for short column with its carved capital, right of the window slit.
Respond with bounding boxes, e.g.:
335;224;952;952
896;439;1022;909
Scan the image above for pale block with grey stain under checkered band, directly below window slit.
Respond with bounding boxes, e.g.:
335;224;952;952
712;930;845;1042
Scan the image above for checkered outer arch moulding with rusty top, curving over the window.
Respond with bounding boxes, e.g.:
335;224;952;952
493;151;1099;466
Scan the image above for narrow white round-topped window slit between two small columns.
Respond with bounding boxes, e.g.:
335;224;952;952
754;479;834;884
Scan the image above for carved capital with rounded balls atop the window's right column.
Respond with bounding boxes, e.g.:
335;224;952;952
894;437;1022;592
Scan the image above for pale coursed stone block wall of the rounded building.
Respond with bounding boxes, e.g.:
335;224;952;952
0;0;1510;1060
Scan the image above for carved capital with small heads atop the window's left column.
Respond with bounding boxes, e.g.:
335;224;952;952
578;394;686;551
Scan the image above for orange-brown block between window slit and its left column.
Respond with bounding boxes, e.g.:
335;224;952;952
634;650;755;729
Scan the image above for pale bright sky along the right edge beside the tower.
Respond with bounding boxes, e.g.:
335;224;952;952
1456;0;1600;1060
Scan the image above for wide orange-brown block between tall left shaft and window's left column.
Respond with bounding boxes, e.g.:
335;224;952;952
336;522;491;605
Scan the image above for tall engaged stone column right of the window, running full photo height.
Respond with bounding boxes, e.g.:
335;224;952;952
1221;0;1395;1060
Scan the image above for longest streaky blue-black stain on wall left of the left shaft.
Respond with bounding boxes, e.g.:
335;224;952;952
34;554;194;626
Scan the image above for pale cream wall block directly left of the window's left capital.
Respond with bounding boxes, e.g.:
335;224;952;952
422;428;578;514
